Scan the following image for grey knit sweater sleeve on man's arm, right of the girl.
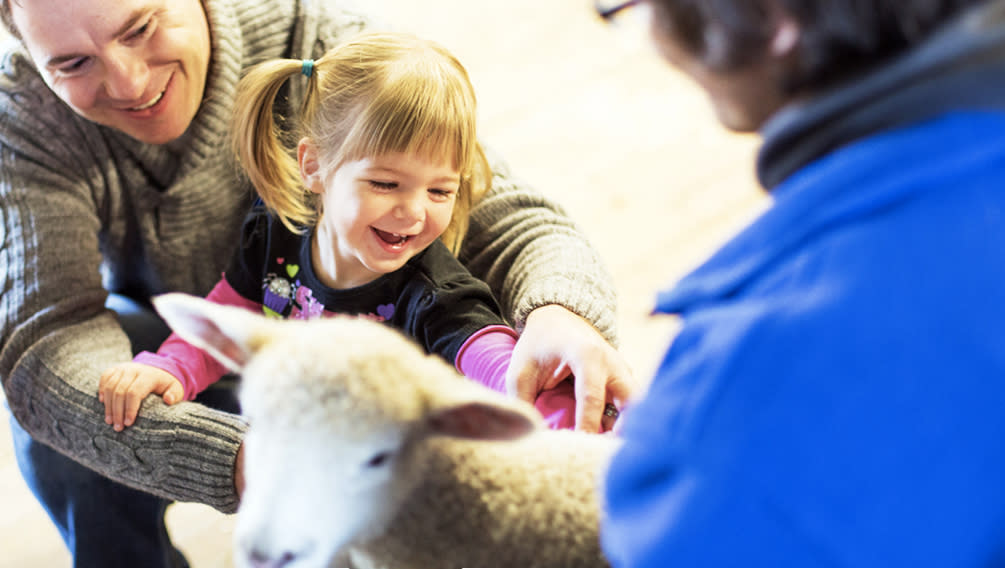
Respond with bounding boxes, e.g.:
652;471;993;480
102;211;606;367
459;144;617;345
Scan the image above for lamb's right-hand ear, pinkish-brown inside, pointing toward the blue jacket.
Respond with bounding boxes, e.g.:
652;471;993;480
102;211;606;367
426;402;537;440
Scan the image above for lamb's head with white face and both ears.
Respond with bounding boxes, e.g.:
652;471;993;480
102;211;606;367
155;294;540;567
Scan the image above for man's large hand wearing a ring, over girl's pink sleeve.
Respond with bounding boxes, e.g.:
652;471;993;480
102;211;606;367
506;305;634;432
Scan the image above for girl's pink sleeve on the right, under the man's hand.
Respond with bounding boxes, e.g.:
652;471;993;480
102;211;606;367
455;326;576;429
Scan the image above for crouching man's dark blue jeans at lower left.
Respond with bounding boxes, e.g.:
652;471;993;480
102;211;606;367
10;296;237;567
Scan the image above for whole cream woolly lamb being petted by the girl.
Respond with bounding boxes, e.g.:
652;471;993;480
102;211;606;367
155;294;617;569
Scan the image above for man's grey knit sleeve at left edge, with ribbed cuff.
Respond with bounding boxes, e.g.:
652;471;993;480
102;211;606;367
0;55;246;512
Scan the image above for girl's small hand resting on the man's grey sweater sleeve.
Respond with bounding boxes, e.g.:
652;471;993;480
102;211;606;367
97;362;185;431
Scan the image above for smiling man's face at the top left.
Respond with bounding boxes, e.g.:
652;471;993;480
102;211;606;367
11;0;210;144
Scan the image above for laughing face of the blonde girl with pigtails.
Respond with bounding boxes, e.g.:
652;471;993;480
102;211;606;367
299;148;460;289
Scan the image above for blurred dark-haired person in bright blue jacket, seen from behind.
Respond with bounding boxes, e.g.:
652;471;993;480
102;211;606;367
602;0;1005;567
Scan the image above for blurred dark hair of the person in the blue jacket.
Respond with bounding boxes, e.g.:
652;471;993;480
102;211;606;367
649;0;985;90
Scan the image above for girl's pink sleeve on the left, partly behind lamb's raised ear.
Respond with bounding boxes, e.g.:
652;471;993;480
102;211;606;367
133;278;261;401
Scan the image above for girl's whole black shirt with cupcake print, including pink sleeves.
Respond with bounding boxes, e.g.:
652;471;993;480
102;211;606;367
135;207;575;428
